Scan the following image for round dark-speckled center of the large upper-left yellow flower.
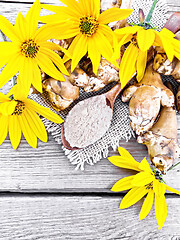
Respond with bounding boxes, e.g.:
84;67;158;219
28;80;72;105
21;39;39;58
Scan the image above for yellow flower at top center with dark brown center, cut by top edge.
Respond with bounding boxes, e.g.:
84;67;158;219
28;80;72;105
40;0;133;73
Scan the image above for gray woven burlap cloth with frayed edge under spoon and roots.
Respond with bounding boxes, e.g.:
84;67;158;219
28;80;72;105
31;0;174;170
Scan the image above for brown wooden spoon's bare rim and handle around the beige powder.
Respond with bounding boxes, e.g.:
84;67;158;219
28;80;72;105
61;83;122;150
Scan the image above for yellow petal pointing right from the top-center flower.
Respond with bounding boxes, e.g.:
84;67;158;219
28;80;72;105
98;8;133;24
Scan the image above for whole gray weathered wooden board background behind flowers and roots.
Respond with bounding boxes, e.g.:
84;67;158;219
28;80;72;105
0;0;180;240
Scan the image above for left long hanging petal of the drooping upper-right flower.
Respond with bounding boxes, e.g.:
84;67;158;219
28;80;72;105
119;43;139;88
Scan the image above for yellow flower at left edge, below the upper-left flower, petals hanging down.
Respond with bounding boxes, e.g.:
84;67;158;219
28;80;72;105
0;85;63;149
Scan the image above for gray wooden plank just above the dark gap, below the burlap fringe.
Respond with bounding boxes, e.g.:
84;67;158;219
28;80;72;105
0;136;180;192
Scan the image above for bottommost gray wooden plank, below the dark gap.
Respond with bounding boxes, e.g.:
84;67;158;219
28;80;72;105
0;196;180;240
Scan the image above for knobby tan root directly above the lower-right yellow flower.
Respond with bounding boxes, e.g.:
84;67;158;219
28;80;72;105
137;107;180;174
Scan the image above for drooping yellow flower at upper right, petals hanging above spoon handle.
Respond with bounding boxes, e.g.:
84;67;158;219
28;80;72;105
113;26;180;87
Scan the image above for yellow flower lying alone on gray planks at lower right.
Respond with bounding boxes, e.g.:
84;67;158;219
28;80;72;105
108;147;180;229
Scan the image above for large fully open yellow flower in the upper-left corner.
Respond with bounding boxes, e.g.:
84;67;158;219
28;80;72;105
0;0;68;95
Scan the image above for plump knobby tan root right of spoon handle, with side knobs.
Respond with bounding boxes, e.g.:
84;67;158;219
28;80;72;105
122;62;174;135
